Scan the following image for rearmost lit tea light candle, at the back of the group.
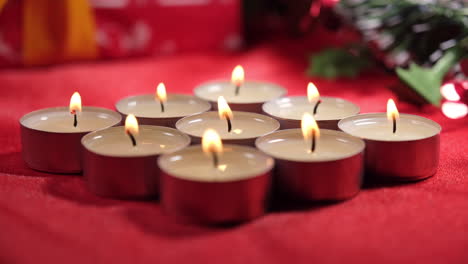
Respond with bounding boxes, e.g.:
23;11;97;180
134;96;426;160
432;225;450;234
194;66;287;113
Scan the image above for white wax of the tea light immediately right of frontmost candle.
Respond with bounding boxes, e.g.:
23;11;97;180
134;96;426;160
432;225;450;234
255;129;365;162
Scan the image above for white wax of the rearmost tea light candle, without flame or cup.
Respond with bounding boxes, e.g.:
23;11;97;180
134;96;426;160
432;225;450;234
194;81;287;103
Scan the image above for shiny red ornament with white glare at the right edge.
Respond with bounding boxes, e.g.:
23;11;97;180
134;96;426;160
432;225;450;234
440;80;468;119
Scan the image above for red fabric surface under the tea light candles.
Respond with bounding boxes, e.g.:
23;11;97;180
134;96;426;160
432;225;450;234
0;38;468;264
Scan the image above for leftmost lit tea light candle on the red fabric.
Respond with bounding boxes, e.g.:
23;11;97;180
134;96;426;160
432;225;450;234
19;93;122;173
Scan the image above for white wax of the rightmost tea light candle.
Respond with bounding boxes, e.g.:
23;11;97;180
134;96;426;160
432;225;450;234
338;113;441;141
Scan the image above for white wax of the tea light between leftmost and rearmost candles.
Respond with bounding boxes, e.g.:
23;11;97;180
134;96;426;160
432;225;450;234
115;94;211;118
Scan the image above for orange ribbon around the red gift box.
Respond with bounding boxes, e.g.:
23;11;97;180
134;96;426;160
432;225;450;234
22;0;98;66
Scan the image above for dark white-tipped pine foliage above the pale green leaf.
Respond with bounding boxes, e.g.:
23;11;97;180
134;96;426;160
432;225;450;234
337;0;468;66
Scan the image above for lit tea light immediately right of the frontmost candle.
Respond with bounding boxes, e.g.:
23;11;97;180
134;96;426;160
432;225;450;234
256;113;365;201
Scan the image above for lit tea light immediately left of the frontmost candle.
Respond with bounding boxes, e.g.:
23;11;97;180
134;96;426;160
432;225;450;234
81;114;190;199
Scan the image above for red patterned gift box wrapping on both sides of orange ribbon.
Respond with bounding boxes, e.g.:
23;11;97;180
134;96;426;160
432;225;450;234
0;0;242;66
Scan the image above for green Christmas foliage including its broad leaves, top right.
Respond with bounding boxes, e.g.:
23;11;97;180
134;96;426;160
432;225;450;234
314;0;468;105
